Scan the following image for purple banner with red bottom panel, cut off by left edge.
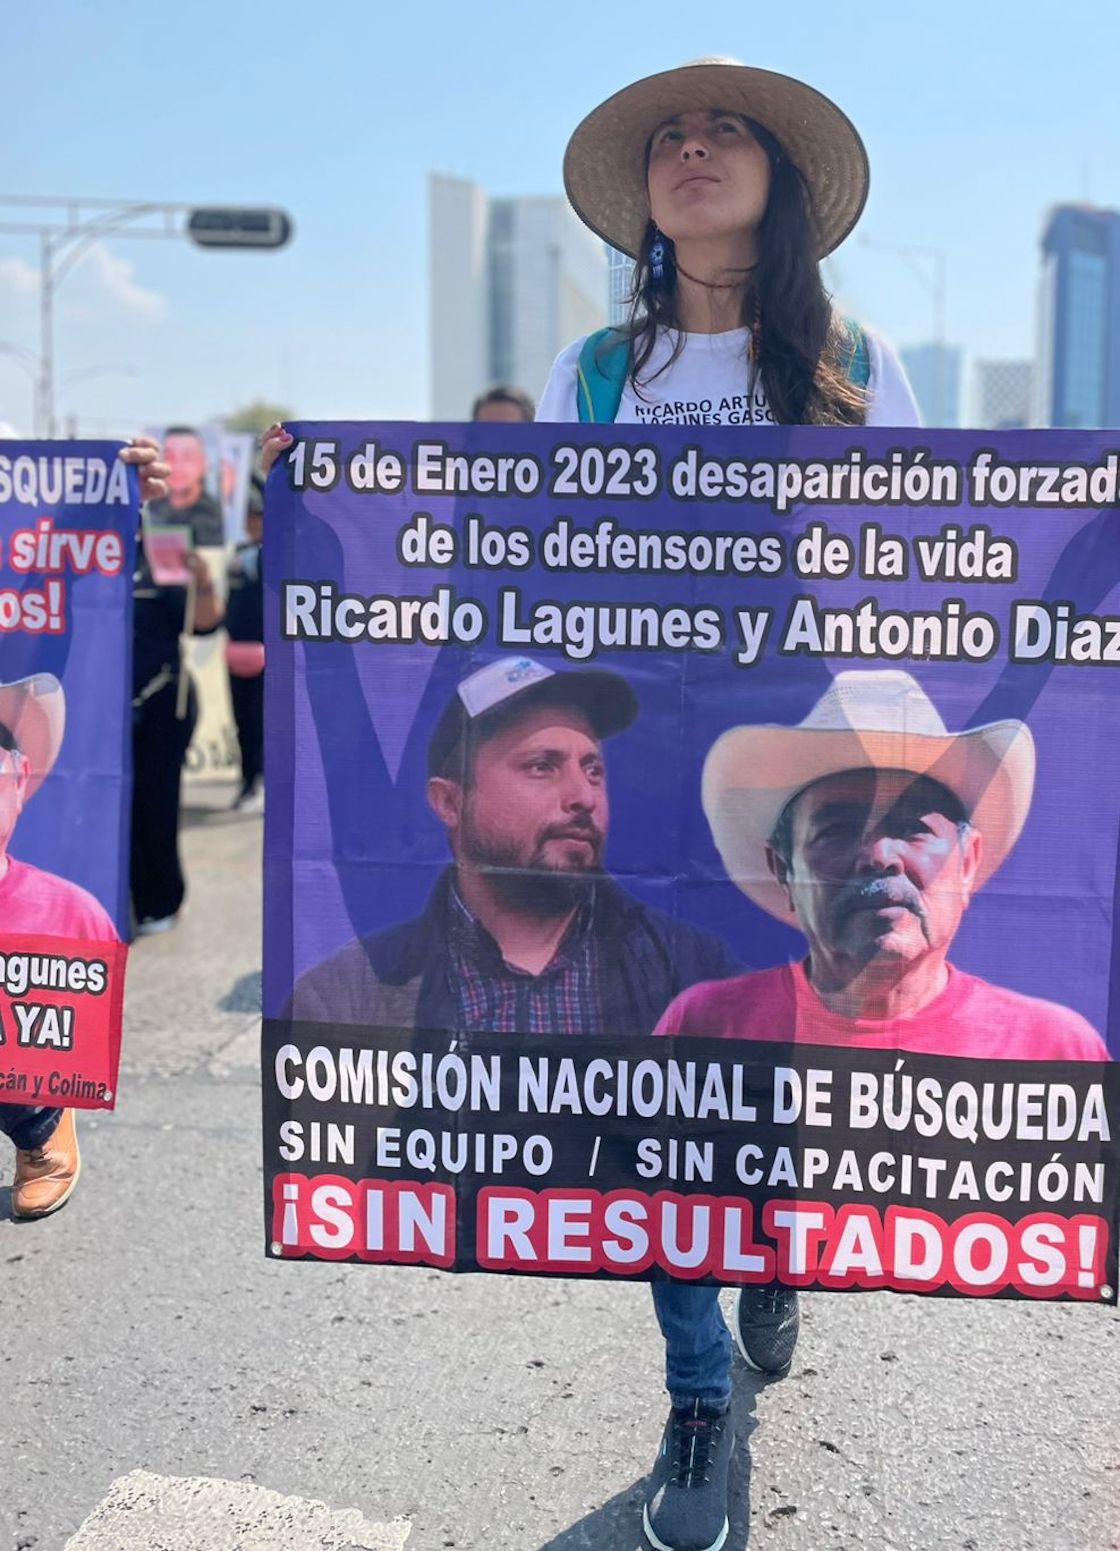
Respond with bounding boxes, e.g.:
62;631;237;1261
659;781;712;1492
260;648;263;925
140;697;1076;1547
0;442;140;1120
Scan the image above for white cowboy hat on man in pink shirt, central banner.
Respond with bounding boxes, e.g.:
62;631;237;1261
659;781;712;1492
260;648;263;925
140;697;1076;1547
701;668;1035;921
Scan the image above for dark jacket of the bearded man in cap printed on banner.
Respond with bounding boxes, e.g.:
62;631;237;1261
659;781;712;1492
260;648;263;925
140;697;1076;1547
289;869;741;1035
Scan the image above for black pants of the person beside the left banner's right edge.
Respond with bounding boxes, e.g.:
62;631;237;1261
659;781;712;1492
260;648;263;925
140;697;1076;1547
130;679;199;921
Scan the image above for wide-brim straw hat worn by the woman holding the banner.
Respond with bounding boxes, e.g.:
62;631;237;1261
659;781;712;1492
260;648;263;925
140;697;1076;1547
565;59;870;259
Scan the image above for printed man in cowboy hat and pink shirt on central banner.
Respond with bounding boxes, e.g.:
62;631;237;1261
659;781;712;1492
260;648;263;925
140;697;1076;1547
656;668;1108;1061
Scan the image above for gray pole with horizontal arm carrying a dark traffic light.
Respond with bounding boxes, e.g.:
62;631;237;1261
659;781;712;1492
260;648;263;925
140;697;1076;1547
0;194;292;437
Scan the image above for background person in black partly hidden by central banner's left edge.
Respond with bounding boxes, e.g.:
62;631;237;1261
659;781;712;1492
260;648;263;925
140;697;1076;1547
225;475;264;813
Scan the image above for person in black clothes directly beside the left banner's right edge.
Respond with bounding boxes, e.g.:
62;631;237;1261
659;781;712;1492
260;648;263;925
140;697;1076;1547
130;544;225;937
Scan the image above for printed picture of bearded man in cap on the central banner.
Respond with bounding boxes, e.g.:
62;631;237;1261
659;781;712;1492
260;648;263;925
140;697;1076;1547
290;658;738;1035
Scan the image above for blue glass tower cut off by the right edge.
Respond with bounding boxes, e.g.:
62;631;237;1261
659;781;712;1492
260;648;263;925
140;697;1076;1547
1035;205;1120;427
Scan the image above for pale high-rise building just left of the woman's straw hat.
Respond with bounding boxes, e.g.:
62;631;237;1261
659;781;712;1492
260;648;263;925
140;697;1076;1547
428;174;608;420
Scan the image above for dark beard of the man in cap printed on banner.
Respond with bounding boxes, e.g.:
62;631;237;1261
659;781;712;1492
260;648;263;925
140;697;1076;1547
458;816;605;921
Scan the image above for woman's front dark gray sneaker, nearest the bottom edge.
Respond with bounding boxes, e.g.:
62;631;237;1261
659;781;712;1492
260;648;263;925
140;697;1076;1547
642;1401;734;1551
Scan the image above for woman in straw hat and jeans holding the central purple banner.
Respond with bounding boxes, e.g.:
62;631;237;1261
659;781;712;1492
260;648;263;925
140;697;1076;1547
537;60;918;1551
